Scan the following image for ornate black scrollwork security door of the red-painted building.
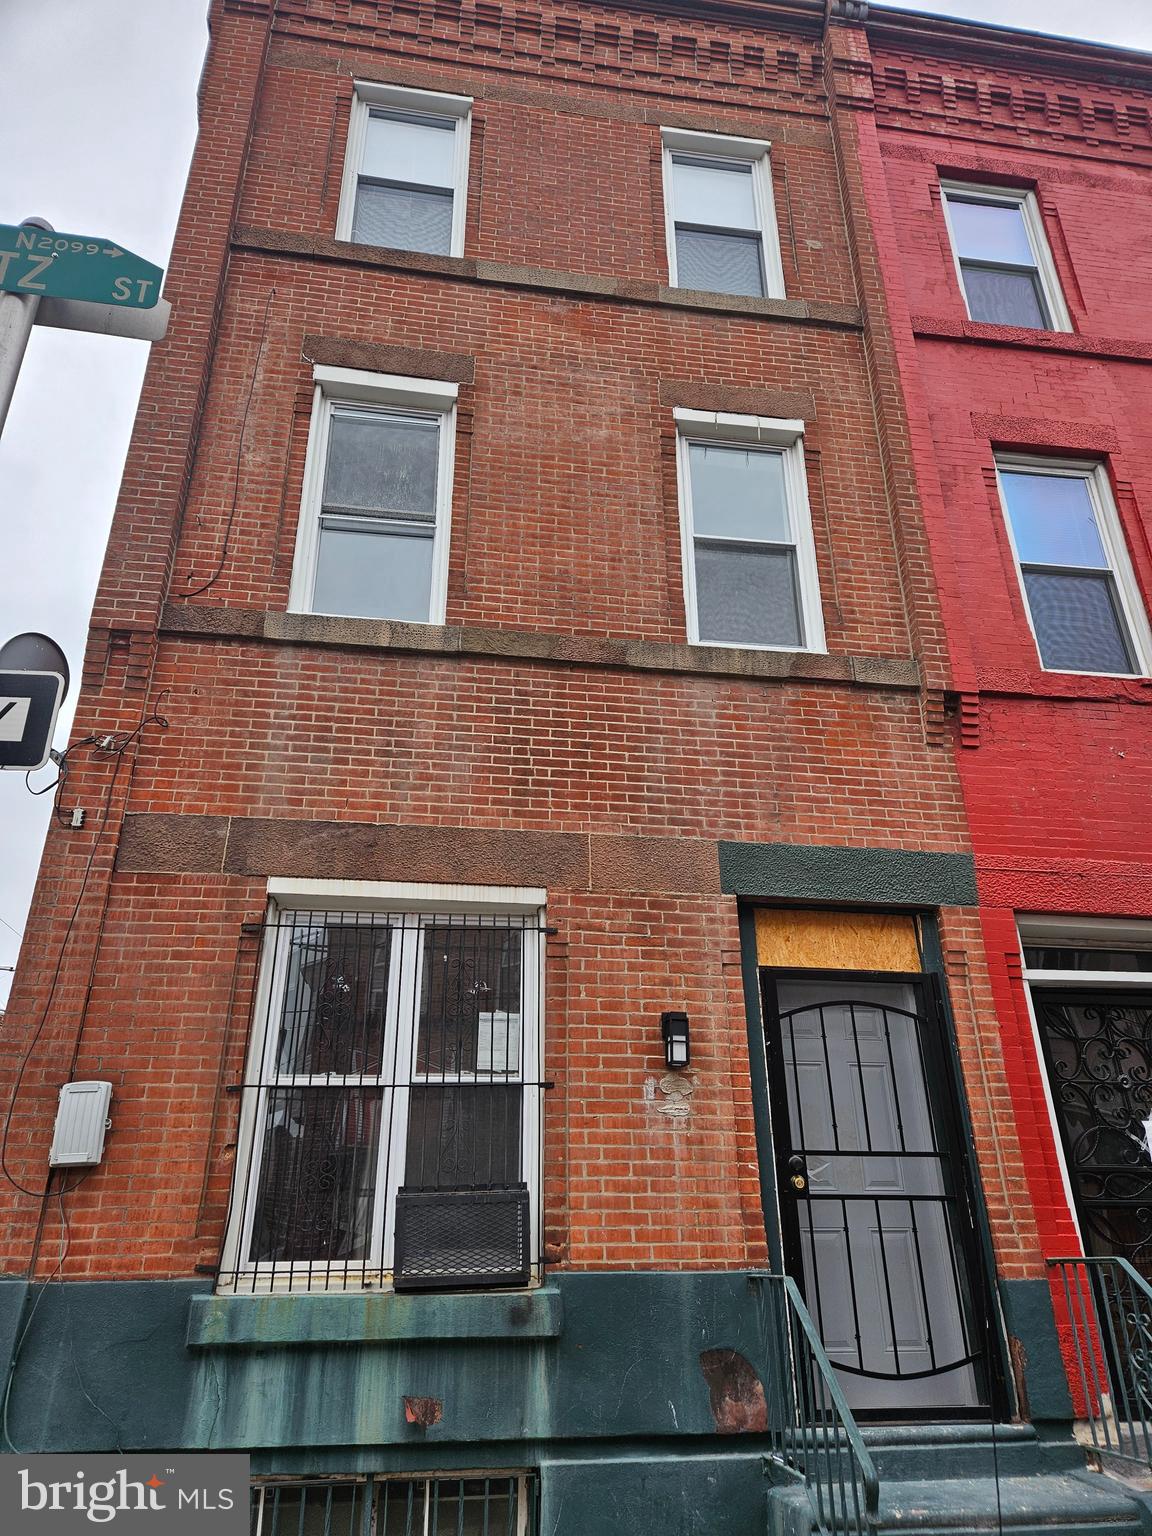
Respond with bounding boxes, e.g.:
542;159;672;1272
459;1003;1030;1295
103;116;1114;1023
1032;988;1152;1279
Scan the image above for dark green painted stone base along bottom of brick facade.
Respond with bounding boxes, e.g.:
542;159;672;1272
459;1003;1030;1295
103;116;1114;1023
0;1272;1069;1536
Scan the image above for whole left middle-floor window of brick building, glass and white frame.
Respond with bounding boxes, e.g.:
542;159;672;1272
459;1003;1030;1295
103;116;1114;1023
289;366;456;624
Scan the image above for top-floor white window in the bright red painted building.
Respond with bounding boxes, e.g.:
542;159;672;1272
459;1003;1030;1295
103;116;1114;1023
940;181;1072;330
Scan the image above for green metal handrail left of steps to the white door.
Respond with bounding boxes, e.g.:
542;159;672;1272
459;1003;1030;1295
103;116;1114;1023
751;1273;880;1536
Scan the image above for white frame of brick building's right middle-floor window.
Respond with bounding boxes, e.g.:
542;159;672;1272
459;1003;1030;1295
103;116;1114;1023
673;407;828;654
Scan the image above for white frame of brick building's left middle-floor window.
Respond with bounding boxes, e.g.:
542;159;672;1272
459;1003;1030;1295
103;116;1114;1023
289;364;459;624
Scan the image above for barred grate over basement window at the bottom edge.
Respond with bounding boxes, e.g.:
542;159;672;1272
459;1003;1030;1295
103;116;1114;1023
250;1473;536;1536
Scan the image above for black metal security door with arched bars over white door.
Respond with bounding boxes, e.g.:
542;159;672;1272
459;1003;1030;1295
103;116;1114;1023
763;972;988;1418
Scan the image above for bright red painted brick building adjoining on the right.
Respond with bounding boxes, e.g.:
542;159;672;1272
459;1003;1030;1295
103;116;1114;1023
869;17;1152;1269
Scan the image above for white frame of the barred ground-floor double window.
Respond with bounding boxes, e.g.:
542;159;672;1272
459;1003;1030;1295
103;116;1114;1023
220;876;547;1295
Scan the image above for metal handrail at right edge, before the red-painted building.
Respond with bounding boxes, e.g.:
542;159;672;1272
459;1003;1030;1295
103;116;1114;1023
1046;1255;1152;1468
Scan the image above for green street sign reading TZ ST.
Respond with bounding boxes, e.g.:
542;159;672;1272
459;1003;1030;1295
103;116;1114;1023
0;224;164;309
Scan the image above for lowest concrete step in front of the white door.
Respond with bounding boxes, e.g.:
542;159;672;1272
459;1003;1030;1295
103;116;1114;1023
880;1471;1141;1536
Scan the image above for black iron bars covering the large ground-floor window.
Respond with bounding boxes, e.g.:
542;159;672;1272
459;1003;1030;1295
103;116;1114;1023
218;909;544;1292
